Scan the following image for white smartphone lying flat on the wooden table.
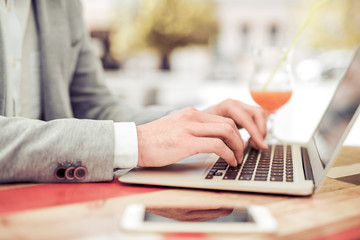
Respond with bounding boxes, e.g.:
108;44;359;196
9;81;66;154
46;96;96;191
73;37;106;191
121;204;277;233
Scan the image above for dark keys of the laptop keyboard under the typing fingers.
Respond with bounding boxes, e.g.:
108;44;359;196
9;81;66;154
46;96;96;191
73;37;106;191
205;145;294;182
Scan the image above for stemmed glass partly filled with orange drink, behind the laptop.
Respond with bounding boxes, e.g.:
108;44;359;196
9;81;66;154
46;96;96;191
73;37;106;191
249;47;293;144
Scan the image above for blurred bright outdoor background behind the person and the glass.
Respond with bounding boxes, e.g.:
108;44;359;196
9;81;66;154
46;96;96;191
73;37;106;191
83;0;360;145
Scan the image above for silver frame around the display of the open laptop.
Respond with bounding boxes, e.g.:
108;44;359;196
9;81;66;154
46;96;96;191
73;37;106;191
307;47;360;189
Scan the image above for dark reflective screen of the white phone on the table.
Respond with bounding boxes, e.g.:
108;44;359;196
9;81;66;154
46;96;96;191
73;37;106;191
144;208;254;223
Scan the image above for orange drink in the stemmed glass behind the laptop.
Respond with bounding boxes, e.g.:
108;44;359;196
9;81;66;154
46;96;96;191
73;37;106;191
250;91;292;113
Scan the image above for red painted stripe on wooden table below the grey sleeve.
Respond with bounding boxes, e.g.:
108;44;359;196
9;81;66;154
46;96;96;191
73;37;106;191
0;179;165;214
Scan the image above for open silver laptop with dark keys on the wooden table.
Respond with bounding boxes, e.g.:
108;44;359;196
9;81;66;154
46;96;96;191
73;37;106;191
119;47;360;196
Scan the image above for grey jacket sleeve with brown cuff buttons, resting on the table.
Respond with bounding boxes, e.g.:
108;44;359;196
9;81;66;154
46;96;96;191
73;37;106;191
0;117;114;182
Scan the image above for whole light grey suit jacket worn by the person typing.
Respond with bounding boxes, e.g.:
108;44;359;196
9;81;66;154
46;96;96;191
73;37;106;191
0;0;173;182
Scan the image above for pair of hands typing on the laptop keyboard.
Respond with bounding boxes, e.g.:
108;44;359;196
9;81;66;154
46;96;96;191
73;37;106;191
137;100;267;167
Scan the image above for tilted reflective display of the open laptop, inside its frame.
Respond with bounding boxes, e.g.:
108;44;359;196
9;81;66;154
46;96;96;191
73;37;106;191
313;49;360;168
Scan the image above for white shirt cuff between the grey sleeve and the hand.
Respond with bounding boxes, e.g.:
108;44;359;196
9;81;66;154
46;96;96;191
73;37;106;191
114;122;138;168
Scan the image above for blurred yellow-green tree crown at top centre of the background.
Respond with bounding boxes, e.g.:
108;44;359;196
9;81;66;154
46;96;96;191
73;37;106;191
111;0;219;69
